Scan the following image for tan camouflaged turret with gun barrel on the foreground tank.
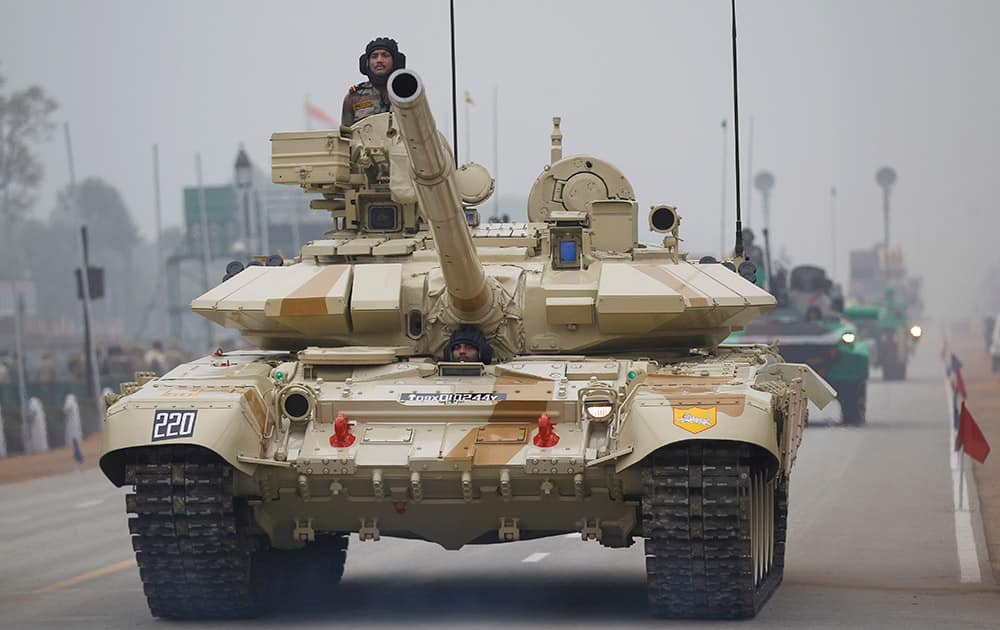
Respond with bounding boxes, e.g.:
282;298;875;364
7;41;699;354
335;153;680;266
192;69;774;360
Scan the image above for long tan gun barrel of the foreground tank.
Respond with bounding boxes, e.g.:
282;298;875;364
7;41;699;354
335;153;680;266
389;69;493;322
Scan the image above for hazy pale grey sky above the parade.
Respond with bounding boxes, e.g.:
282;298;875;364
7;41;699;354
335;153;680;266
0;0;1000;315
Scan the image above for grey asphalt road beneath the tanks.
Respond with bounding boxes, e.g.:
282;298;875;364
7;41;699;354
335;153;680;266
0;339;1000;629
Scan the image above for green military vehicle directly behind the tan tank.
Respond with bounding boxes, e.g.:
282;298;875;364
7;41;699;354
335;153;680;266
726;265;869;425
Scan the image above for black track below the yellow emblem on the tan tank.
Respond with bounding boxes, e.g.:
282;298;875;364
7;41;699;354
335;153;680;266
642;441;787;619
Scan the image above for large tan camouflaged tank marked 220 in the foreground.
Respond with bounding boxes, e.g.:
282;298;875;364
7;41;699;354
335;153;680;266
100;69;834;618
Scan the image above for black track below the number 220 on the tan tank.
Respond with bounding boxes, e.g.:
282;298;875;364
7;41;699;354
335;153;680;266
125;447;263;619
